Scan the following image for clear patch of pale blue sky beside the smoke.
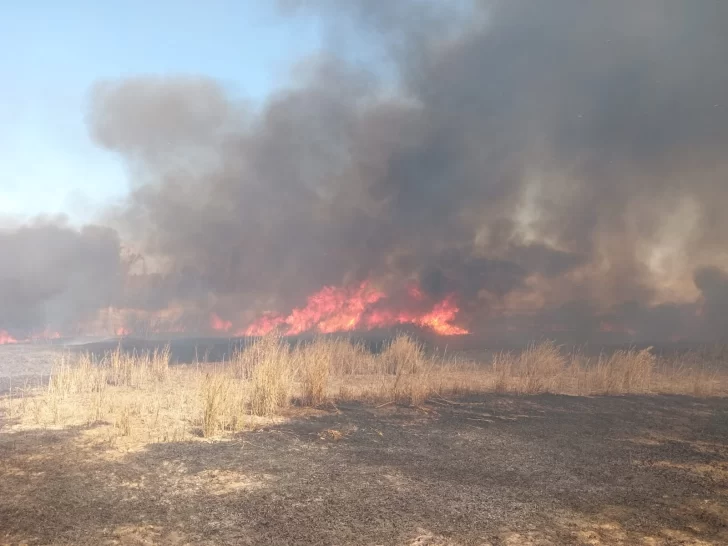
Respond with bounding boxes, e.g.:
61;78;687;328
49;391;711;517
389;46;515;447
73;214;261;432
0;0;321;222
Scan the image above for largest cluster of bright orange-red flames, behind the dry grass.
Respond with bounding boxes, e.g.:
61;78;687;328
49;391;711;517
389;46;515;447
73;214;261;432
239;282;468;336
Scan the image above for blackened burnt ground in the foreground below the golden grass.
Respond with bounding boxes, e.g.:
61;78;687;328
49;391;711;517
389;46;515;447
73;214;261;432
0;395;728;546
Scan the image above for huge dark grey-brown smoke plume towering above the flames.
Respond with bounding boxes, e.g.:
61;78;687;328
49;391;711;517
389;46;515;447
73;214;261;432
9;0;728;339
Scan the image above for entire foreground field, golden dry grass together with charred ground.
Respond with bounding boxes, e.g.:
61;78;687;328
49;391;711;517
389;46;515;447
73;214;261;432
0;336;728;546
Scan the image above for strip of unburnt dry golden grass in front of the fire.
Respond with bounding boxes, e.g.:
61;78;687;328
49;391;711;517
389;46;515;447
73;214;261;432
0;334;728;445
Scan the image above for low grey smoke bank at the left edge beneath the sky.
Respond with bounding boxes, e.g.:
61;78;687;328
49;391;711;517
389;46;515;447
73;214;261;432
0;219;123;334
